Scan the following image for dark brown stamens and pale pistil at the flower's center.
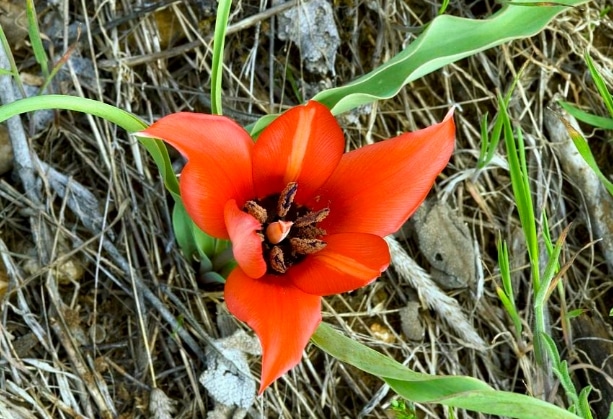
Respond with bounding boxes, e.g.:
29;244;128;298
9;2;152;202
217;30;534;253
243;182;330;275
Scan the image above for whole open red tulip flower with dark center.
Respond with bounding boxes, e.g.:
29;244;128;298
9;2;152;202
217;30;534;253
139;101;455;393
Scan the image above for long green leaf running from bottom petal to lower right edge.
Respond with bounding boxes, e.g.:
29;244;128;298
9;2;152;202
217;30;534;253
311;323;578;419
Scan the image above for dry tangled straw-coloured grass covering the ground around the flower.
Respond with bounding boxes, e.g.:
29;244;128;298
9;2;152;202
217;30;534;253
0;0;613;418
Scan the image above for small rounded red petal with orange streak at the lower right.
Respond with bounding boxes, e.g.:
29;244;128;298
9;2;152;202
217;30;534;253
287;233;390;296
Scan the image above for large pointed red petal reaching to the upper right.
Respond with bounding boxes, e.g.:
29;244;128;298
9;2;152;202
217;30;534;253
310;112;455;237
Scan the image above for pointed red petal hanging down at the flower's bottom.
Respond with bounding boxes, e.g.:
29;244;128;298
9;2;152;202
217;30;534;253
224;268;321;394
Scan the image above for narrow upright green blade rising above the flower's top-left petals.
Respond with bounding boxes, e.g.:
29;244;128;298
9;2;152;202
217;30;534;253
211;0;232;115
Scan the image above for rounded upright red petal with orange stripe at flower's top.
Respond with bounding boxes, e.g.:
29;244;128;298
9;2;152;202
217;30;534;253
253;101;345;202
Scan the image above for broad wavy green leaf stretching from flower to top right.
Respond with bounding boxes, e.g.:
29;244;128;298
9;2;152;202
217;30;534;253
314;0;587;115
